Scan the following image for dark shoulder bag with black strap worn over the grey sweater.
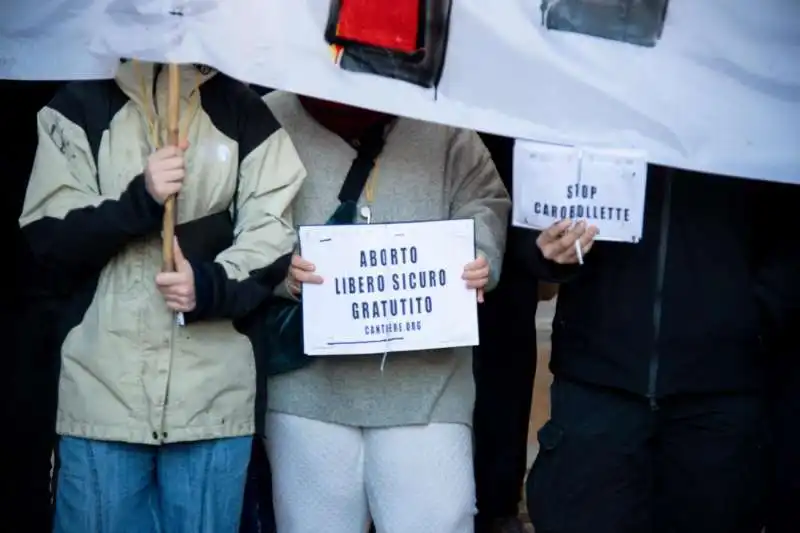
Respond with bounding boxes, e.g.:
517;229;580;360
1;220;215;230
239;122;386;376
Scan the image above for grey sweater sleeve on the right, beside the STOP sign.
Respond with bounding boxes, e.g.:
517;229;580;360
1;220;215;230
445;129;511;290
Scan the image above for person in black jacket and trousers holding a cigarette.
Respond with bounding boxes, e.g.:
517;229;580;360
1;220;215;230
527;167;797;533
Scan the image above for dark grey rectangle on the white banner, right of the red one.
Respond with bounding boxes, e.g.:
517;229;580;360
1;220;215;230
541;0;669;47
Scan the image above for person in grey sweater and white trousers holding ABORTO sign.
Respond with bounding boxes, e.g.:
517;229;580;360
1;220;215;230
265;92;511;533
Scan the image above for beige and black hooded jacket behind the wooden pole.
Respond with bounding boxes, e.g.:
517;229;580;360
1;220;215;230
20;62;305;444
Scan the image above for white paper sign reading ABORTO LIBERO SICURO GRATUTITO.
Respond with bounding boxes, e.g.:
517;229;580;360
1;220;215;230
299;219;478;355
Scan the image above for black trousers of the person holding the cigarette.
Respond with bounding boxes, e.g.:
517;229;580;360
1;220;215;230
527;378;768;533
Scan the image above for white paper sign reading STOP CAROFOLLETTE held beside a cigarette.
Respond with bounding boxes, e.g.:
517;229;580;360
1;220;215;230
512;140;647;243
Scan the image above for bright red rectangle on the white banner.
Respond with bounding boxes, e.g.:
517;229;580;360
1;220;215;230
336;0;420;53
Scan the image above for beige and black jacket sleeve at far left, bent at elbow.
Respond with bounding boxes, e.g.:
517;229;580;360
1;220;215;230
20;86;163;284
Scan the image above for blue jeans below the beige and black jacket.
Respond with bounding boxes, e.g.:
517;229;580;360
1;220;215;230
53;437;253;533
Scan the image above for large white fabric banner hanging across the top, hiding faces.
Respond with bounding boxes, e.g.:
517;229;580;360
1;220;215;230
0;0;800;182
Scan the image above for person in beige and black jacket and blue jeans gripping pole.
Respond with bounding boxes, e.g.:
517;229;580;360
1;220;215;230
20;61;305;533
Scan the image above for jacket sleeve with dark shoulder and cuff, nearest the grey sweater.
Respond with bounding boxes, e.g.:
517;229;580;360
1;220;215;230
186;85;306;322
